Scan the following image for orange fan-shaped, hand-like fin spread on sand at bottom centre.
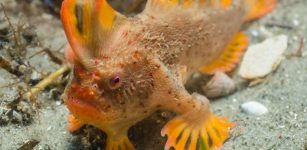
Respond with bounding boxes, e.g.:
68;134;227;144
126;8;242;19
161;113;235;150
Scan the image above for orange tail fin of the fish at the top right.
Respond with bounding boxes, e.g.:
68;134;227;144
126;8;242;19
245;0;277;21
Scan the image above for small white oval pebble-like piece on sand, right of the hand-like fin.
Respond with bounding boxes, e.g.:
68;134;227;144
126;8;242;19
241;101;268;116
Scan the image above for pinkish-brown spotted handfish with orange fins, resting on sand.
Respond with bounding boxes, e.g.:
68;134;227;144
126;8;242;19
61;0;275;150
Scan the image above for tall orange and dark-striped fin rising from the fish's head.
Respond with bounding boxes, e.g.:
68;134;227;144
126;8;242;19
61;0;125;65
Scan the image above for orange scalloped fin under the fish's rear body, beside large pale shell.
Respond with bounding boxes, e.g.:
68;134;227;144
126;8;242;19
200;32;248;74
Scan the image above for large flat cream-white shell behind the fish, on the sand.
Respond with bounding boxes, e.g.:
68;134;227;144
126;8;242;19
239;35;288;79
